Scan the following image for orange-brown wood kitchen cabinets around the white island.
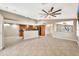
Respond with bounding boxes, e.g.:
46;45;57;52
19;25;45;38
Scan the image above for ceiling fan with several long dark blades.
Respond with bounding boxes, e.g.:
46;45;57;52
42;7;62;17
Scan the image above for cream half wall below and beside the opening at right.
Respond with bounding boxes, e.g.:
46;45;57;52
52;20;77;41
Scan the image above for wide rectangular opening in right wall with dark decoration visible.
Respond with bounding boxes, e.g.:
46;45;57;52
56;21;73;32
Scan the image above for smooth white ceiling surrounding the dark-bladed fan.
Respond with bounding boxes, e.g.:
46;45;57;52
0;3;78;19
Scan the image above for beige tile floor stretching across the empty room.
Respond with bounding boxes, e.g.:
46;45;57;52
0;35;79;56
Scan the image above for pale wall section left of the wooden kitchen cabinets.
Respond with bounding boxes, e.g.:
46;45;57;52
4;24;19;38
